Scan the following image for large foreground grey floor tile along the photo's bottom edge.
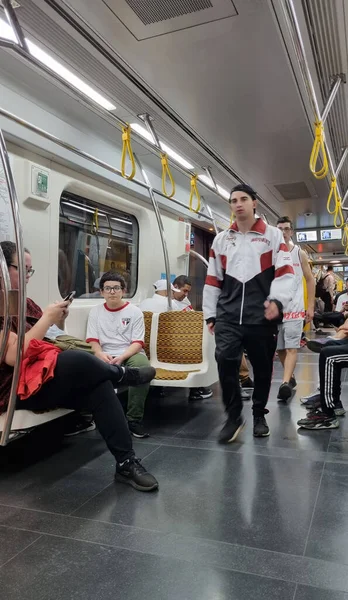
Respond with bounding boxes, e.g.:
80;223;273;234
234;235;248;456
1;537;295;600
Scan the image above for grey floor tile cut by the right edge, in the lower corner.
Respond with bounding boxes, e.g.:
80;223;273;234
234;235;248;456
306;463;348;565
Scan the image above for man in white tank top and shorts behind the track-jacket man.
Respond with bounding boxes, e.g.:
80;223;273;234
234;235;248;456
277;217;315;402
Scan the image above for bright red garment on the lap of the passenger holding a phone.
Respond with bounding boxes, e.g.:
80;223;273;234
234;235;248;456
17;340;61;400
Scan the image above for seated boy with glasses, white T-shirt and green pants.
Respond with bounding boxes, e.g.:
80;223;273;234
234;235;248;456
86;271;152;438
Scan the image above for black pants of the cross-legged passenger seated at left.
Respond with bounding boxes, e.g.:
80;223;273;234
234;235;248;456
17;350;134;462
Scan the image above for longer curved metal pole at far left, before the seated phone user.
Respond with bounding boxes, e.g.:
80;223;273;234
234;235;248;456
0;130;26;446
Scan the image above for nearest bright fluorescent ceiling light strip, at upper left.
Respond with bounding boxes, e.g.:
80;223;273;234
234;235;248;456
0;19;116;110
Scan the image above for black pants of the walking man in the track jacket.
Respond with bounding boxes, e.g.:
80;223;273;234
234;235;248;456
215;320;277;420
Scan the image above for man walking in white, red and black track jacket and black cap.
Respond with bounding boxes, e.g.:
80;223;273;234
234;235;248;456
203;184;294;443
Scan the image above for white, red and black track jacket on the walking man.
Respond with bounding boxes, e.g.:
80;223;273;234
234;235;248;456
203;219;294;325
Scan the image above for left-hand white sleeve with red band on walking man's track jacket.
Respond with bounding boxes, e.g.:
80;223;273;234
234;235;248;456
203;234;224;320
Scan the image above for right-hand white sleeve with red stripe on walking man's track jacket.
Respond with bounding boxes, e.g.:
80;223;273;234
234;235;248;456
269;227;295;310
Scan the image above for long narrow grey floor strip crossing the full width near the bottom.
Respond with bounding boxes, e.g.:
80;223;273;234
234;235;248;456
0;506;348;591
